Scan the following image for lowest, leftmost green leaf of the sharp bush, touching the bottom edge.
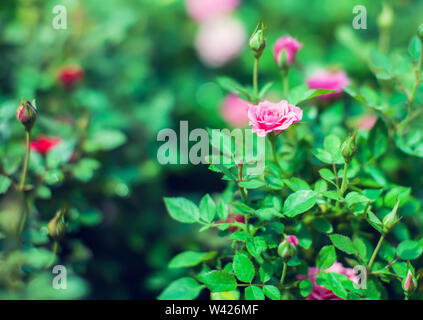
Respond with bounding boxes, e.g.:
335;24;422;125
158;277;204;300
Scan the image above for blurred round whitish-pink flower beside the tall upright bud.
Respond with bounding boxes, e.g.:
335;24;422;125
195;16;246;67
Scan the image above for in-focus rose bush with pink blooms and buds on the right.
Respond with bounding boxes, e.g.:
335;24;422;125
159;19;423;300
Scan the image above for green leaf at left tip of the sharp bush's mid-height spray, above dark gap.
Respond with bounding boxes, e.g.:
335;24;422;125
164;197;200;223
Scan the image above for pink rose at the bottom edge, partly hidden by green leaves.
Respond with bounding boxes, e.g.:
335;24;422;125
298;262;358;300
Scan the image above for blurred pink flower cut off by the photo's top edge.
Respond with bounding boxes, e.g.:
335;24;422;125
185;0;240;21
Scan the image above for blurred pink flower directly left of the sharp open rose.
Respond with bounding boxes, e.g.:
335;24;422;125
221;93;249;127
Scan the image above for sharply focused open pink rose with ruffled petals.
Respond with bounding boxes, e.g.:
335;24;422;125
248;100;303;137
